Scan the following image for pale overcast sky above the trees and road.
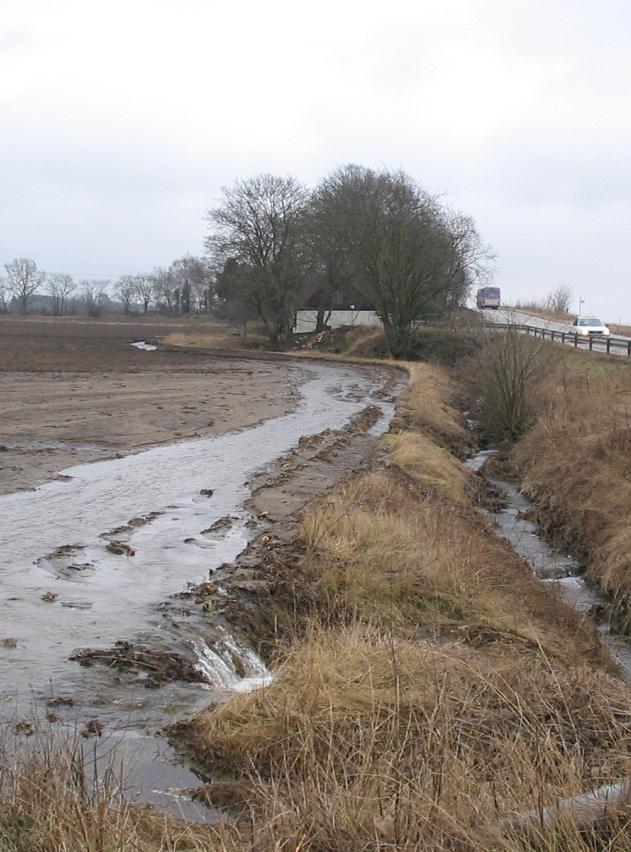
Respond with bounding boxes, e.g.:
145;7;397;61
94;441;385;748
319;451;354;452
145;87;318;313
0;0;631;321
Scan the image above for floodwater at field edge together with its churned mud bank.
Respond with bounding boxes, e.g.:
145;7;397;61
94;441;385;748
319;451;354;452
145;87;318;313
0;364;402;820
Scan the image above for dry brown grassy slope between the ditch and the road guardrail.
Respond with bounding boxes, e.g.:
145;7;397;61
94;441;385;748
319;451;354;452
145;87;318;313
464;335;631;632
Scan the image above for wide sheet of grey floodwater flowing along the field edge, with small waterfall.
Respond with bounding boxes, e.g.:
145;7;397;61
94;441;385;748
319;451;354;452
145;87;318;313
0;364;400;819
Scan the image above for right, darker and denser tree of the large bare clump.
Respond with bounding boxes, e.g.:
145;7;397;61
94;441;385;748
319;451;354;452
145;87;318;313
319;165;489;357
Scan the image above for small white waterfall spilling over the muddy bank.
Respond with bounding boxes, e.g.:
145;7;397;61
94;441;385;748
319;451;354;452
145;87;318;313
192;628;274;692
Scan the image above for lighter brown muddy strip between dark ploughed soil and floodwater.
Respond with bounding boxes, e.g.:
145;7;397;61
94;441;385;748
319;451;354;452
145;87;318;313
0;352;305;494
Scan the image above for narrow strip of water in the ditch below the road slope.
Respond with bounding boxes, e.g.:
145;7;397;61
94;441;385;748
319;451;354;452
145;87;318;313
465;449;631;682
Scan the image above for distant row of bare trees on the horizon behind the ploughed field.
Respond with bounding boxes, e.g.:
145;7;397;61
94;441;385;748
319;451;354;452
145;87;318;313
0;255;214;317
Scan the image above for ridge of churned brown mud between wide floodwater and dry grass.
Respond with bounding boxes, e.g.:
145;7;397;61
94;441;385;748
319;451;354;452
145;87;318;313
73;392;399;688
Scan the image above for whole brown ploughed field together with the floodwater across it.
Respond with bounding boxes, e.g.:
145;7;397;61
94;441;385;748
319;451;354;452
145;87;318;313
0;319;403;819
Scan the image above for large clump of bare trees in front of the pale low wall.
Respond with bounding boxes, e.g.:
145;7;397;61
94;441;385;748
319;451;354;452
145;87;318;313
205;165;492;357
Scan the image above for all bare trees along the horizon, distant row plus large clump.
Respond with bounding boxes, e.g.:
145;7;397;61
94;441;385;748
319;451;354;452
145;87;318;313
0;165;493;357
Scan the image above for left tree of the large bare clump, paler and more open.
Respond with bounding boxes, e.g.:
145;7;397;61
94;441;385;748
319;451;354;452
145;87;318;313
206;174;308;343
